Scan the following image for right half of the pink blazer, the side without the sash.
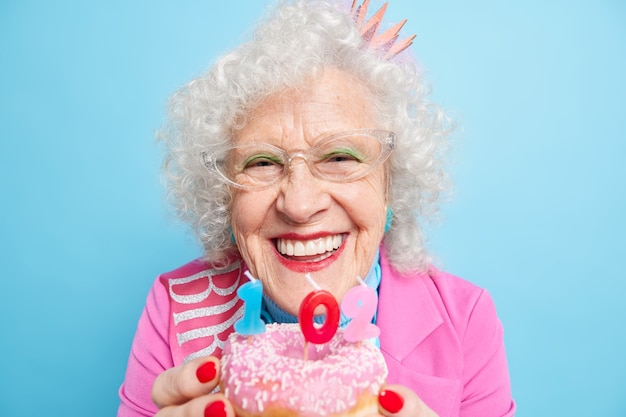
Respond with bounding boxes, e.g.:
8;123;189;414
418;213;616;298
377;252;515;417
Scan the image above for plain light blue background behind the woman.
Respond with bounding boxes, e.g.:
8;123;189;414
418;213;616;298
0;0;626;417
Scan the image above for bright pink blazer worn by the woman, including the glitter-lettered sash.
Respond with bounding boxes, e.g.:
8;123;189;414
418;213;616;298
118;251;515;417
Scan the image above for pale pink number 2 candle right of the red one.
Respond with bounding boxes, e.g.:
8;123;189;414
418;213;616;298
341;277;380;342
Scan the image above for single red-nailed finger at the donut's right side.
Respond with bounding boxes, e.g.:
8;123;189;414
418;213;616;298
378;385;437;417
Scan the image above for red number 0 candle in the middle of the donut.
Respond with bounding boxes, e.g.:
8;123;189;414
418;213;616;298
298;290;339;345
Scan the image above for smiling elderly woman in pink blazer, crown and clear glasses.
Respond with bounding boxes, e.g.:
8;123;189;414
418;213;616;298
118;0;515;417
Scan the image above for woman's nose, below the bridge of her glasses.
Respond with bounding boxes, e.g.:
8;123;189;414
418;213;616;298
276;158;331;224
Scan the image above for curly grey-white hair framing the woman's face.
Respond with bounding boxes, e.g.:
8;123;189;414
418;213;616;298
160;0;448;272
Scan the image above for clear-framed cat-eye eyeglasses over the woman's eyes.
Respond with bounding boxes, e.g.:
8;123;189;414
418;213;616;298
202;129;396;190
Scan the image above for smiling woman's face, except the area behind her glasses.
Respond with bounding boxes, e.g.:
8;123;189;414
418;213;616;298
232;68;386;315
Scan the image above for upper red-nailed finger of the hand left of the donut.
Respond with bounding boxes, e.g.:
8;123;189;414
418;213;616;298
152;357;220;408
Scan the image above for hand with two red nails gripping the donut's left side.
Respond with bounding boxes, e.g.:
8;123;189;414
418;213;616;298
152;357;235;417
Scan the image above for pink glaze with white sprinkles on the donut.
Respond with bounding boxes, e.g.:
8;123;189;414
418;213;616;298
222;323;387;417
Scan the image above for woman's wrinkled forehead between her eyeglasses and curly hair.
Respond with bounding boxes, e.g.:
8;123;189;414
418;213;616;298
233;68;376;149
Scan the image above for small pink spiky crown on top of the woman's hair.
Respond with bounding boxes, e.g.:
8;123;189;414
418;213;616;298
351;0;416;59
